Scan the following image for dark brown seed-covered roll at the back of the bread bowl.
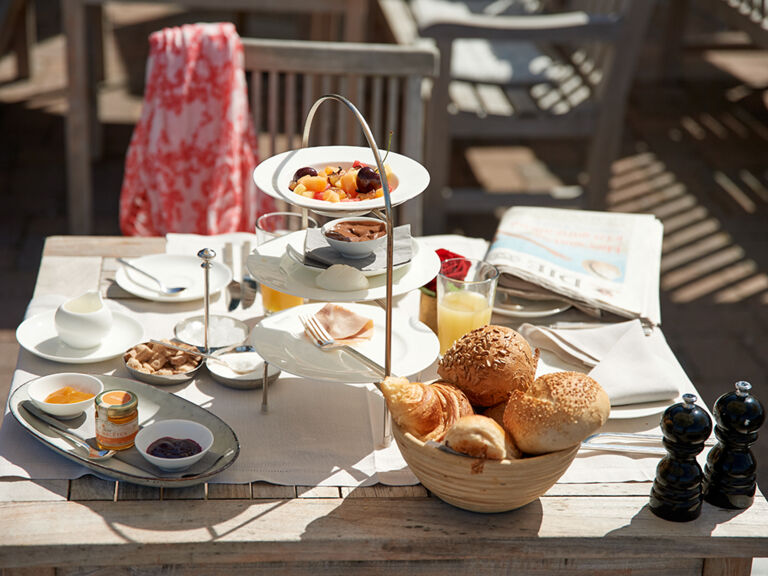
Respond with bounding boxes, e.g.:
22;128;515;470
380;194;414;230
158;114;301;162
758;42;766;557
437;325;539;407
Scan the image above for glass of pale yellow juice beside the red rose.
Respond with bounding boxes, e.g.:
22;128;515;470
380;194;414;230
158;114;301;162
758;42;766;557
437;258;499;355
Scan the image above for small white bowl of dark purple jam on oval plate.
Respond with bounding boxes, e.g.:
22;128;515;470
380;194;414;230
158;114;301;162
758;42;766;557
136;420;213;471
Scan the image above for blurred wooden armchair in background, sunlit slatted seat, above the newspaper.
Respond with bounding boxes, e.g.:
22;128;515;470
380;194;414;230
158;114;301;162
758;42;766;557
379;0;654;232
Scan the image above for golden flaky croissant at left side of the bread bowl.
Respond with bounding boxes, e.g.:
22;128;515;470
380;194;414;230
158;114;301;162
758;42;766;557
381;376;473;442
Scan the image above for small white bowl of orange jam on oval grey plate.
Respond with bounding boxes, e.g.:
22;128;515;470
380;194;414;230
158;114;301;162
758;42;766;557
27;372;104;420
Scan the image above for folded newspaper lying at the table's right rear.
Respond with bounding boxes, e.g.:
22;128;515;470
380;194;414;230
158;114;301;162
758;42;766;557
485;207;663;325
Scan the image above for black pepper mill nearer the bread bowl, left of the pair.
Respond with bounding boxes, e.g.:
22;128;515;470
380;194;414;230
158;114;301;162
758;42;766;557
650;394;712;522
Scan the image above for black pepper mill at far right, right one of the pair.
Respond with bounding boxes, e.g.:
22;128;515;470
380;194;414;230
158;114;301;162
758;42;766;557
704;382;765;510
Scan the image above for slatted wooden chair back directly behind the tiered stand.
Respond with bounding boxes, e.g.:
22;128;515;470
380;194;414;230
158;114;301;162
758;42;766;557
243;38;438;235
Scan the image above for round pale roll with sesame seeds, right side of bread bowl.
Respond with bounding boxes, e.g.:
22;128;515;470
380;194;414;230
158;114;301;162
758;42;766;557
504;372;611;454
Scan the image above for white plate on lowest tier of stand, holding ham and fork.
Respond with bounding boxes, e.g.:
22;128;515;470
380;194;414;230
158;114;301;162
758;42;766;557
250;302;440;384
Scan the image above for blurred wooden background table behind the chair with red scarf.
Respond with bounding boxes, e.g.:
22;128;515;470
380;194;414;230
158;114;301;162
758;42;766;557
62;0;368;234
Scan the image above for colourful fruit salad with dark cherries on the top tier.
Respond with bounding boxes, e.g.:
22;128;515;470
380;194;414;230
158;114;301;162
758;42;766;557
288;160;395;202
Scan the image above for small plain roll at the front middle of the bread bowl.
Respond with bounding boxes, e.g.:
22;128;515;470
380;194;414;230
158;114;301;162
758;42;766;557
445;414;514;460
